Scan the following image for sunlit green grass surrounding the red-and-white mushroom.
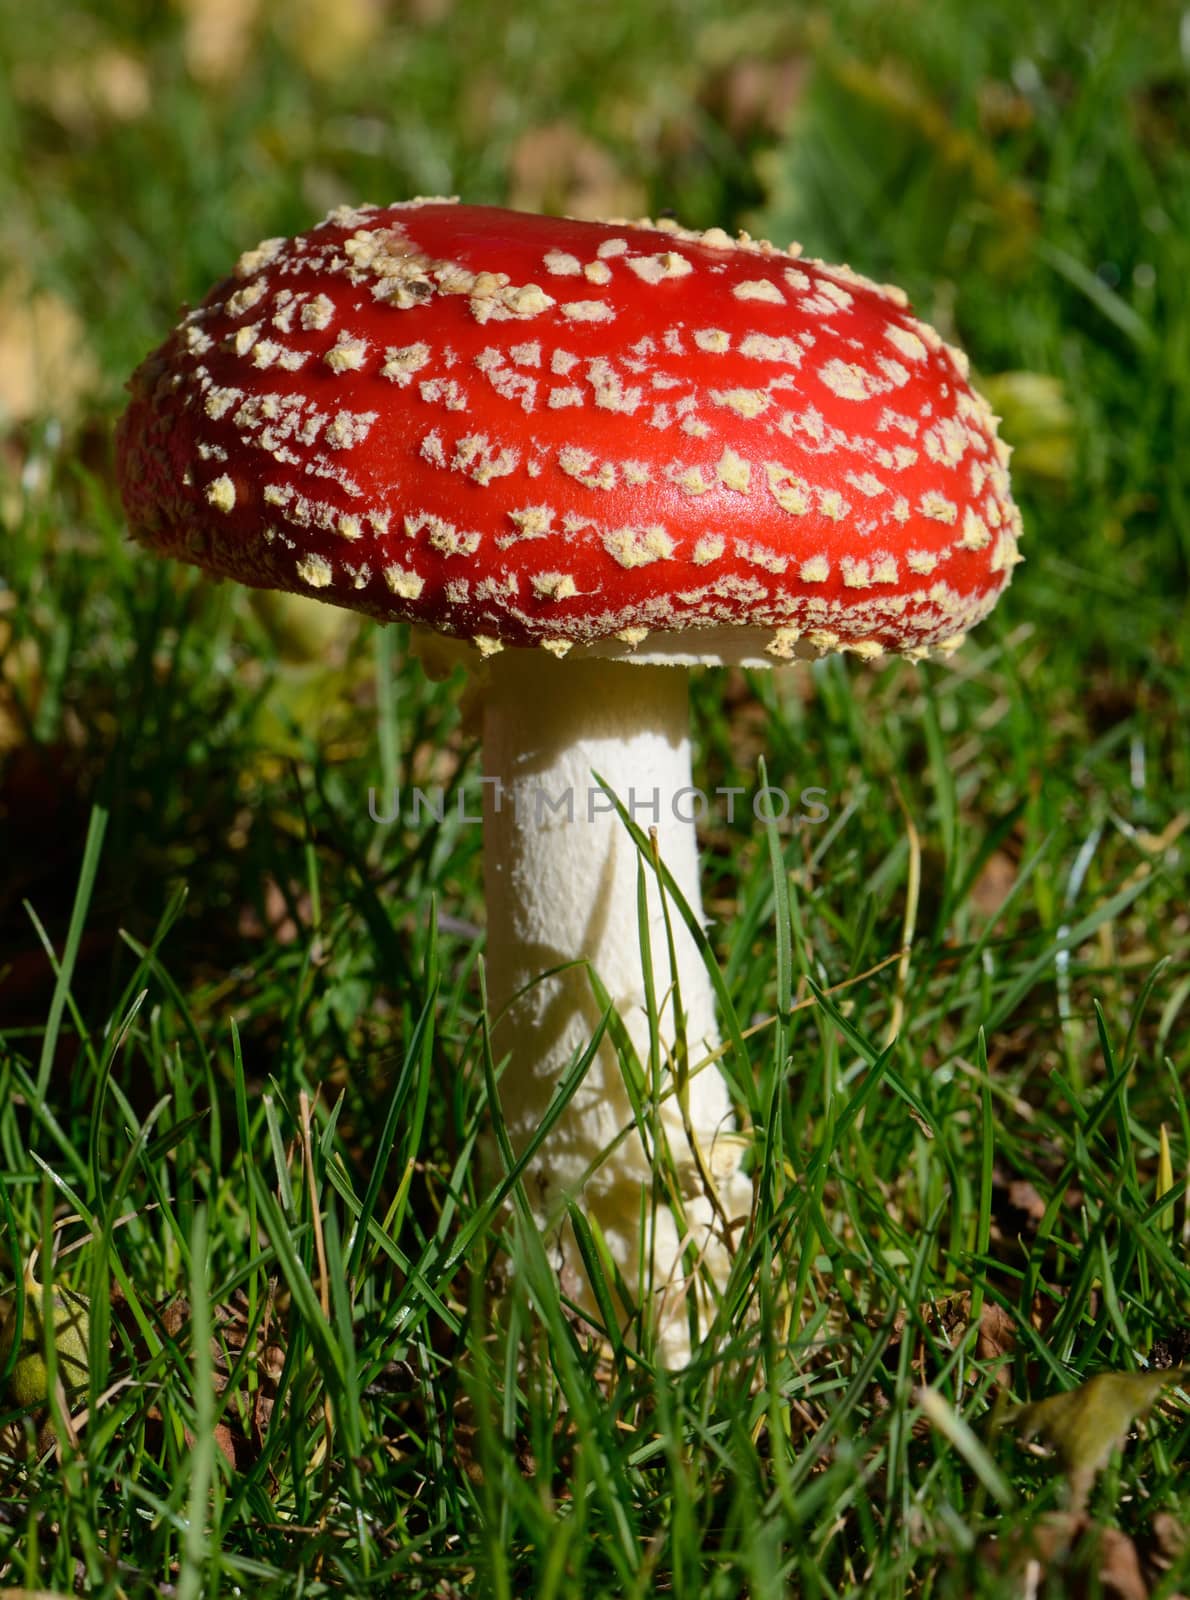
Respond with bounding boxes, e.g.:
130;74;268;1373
0;0;1190;1600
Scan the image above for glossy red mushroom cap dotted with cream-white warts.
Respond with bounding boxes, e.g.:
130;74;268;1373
118;200;1020;661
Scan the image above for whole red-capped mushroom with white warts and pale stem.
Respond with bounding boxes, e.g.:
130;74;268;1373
118;200;1020;1365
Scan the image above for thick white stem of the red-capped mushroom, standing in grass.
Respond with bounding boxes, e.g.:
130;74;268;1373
483;650;750;1365
